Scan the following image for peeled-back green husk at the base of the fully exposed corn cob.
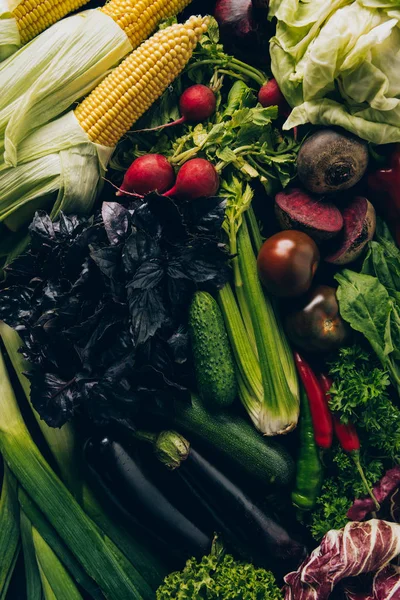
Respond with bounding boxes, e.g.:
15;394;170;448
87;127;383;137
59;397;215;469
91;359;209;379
0;111;114;222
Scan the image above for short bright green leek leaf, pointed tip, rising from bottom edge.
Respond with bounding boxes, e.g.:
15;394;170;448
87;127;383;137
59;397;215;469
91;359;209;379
32;527;83;600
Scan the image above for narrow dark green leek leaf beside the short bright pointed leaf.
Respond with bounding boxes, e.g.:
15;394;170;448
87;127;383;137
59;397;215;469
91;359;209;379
18;487;103;600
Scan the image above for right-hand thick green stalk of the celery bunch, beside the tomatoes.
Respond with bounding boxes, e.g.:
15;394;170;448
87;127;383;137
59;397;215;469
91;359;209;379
238;220;299;435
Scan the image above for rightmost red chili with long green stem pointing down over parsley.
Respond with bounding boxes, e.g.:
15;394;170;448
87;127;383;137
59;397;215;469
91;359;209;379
318;373;380;510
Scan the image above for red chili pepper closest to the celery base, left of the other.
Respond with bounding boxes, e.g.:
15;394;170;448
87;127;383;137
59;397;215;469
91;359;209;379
294;352;333;450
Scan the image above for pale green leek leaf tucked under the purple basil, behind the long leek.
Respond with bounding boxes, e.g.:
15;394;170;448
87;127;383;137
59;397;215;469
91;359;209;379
0;321;82;501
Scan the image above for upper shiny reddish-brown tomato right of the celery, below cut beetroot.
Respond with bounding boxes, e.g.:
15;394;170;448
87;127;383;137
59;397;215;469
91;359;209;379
257;230;319;298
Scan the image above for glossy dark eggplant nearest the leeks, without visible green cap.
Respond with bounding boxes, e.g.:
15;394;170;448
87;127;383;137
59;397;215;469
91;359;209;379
85;437;212;560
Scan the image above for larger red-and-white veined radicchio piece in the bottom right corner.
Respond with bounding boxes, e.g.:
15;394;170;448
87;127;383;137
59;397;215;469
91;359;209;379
285;519;400;600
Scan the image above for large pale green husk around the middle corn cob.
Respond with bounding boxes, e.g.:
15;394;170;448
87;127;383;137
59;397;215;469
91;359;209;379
0;10;132;168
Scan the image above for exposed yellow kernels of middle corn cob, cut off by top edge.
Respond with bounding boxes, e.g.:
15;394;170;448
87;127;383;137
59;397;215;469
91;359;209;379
100;0;191;49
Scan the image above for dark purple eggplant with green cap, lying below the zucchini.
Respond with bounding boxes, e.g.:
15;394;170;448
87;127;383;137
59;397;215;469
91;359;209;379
154;431;307;574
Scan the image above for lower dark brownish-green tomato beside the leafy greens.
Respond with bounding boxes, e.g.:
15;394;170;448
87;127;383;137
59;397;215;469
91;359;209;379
285;285;350;352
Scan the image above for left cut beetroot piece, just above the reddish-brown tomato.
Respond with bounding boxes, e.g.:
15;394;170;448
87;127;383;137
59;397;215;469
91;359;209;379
275;188;343;241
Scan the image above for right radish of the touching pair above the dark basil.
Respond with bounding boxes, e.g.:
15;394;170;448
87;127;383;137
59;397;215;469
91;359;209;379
164;158;219;200
